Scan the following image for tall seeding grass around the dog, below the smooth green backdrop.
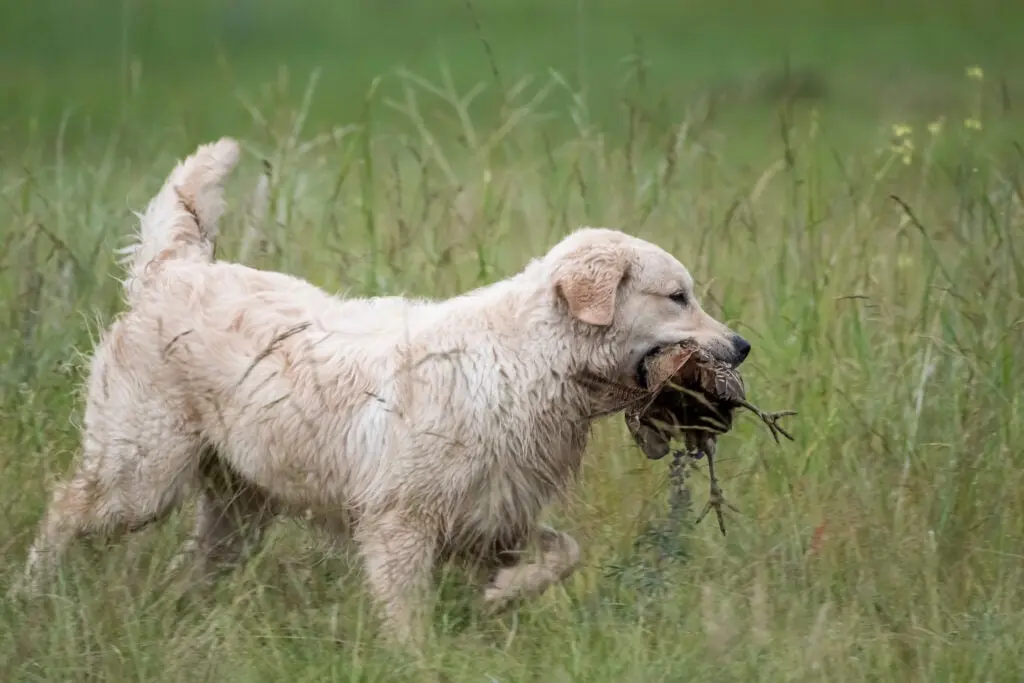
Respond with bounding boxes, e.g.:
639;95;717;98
0;61;1024;683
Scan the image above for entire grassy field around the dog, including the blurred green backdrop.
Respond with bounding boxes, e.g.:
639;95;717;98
0;0;1024;683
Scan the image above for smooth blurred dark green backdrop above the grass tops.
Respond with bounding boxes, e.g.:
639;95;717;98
0;0;1024;151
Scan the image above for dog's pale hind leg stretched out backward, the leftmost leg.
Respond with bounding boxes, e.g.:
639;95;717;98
10;434;199;594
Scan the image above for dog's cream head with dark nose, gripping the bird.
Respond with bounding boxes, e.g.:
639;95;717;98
544;228;751;387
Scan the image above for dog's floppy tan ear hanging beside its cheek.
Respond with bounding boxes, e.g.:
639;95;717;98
554;245;629;327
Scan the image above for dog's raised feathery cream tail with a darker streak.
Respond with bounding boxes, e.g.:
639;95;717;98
119;137;239;299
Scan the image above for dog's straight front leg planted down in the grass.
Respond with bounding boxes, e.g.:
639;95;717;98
355;512;437;649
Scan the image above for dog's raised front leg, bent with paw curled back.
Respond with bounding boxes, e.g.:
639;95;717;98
483;526;580;611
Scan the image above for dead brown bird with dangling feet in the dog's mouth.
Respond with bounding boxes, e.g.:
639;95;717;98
589;342;796;533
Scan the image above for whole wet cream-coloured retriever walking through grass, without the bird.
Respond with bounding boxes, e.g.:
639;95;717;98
12;138;750;640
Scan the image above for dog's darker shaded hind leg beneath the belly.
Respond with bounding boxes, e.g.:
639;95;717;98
170;450;278;583
